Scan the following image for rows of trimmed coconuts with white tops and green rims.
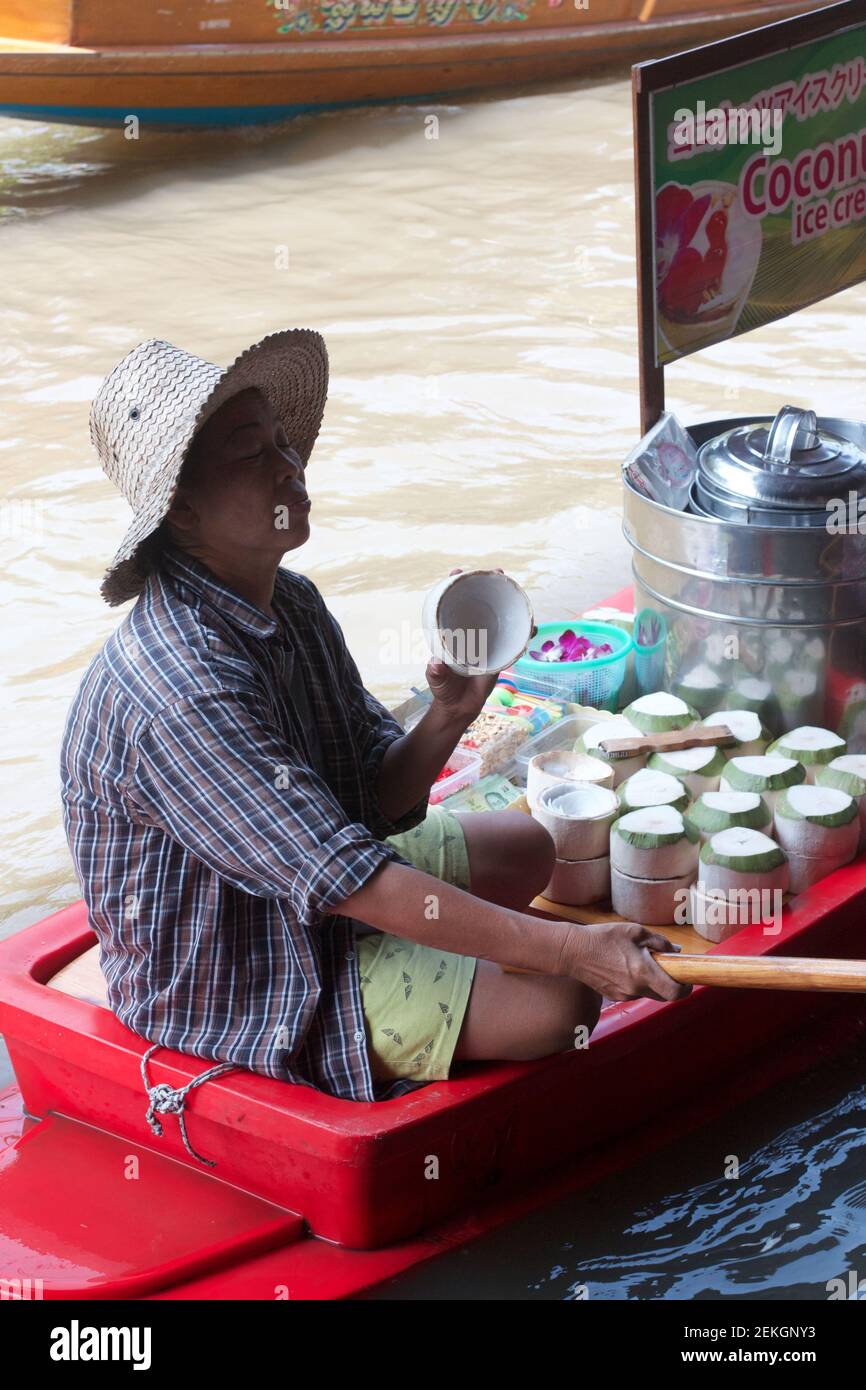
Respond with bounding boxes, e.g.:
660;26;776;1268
530;692;866;941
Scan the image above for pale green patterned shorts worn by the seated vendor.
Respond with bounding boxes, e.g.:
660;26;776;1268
357;806;477;1081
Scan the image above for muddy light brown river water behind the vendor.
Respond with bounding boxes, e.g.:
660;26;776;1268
0;75;866;1297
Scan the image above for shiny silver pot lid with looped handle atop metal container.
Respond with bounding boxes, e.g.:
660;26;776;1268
696;406;866;512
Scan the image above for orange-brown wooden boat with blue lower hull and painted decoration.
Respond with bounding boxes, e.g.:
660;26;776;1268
0;0;819;128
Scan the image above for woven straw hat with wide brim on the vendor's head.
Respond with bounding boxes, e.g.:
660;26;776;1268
90;328;328;605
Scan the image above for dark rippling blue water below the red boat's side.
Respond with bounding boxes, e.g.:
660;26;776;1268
368;1040;866;1301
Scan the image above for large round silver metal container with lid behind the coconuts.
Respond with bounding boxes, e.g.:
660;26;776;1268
623;407;866;752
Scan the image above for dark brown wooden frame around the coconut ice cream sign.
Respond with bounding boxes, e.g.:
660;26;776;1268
631;0;866;435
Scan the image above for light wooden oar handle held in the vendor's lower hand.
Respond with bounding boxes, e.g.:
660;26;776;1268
652;951;866;992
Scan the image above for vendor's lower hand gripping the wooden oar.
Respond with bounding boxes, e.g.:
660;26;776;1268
563;922;692;1001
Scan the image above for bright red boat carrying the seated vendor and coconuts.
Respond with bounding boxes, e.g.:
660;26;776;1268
0;591;866;1301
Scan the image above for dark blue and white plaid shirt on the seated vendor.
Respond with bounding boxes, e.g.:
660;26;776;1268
61;550;427;1101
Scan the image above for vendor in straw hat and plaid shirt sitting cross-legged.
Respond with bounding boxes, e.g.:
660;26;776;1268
63;329;688;1101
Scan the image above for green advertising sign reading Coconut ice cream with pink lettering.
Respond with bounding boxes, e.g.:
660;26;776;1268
635;0;866;422
